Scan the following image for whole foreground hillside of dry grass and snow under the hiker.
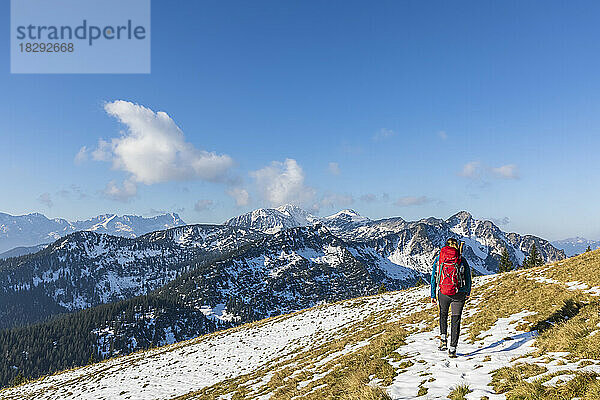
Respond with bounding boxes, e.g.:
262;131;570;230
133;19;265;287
0;251;600;399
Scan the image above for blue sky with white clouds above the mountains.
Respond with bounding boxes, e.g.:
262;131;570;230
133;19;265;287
0;1;600;239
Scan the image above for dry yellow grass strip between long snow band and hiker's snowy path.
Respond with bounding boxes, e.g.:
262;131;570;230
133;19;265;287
173;304;420;400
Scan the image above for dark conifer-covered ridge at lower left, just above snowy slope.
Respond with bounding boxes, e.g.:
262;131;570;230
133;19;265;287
0;293;225;387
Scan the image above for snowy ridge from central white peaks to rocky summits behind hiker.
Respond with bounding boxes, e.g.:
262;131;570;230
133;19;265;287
227;206;565;274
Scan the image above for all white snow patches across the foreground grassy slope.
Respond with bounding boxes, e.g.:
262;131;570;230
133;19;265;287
0;268;600;400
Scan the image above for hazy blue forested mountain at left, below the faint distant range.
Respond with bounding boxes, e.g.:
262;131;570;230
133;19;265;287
0;225;264;329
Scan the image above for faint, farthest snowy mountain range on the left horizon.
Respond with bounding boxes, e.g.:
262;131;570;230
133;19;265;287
0;213;185;254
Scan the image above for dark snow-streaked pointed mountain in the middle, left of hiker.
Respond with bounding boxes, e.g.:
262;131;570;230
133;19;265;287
158;225;425;322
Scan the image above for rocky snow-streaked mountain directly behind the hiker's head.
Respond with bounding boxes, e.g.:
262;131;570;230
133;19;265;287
340;211;565;274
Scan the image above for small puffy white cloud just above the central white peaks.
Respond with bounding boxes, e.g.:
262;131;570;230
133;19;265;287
250;158;315;206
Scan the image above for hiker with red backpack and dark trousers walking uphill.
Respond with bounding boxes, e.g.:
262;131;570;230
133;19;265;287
431;238;471;358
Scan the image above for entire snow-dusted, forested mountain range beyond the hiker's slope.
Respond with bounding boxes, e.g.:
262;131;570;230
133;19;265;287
0;205;565;386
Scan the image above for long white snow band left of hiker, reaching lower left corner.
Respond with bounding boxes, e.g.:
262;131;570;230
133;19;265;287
0;287;429;400
